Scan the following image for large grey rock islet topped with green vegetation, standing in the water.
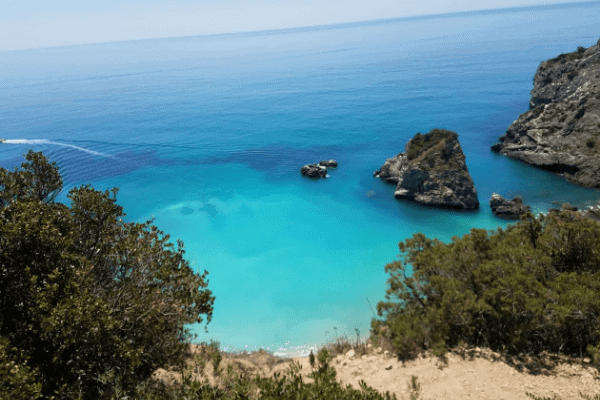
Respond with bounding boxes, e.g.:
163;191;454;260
373;129;479;210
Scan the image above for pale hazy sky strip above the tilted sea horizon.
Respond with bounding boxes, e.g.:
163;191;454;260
0;0;592;51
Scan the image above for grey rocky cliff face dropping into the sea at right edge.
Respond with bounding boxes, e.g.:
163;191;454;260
492;41;600;187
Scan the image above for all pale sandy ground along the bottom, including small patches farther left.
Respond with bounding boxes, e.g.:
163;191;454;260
156;347;600;400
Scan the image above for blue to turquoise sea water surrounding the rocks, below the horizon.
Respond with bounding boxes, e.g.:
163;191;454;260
0;2;600;355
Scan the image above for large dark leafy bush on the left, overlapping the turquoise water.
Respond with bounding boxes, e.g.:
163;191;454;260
0;151;214;398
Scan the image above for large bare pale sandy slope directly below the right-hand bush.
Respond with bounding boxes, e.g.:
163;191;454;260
290;351;600;400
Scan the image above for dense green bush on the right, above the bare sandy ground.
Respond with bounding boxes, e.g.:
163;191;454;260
372;211;600;365
